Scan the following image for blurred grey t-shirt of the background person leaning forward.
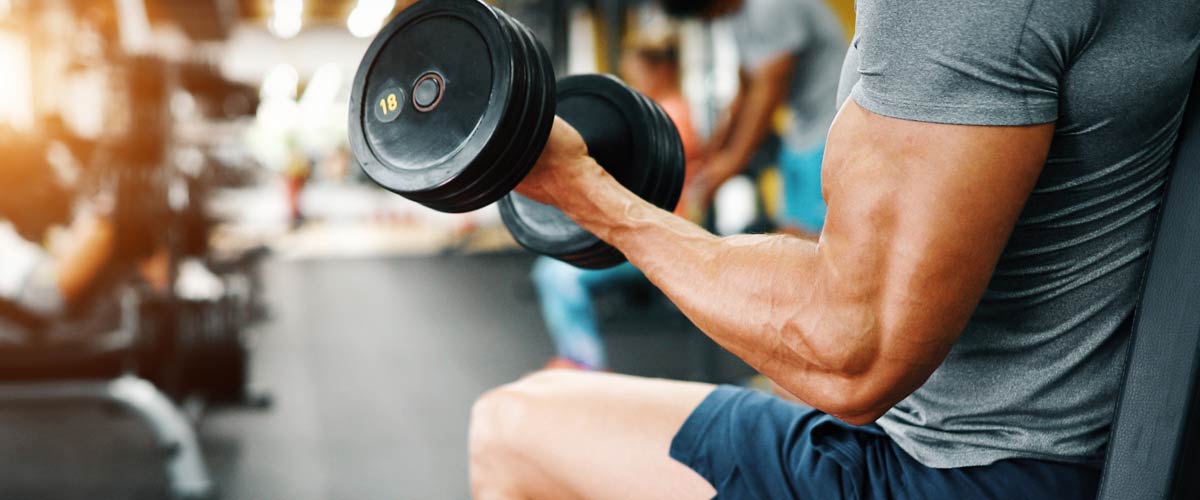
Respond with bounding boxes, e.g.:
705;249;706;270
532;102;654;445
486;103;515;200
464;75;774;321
730;0;846;151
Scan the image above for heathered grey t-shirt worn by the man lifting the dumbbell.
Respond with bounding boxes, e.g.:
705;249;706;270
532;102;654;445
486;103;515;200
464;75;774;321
839;0;1200;468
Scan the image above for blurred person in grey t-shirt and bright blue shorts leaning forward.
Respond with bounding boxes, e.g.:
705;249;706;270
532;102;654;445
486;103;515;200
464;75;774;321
661;0;846;235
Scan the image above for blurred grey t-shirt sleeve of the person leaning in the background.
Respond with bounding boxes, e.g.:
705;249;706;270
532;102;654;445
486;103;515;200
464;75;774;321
733;0;810;71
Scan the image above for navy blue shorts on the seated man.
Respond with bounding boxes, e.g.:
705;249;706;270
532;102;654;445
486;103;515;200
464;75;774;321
671;386;1100;500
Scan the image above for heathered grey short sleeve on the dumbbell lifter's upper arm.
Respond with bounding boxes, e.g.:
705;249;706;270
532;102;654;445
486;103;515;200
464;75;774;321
851;0;1088;126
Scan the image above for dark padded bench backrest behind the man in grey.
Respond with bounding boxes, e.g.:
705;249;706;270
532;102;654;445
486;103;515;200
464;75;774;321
1099;63;1200;500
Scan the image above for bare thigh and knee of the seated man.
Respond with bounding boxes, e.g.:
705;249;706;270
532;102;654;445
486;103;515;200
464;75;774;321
470;371;715;500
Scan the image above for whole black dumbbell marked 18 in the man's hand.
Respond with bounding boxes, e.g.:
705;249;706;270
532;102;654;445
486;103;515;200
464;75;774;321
349;0;684;269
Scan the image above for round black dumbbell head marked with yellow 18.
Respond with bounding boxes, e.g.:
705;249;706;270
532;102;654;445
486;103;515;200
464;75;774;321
349;0;553;212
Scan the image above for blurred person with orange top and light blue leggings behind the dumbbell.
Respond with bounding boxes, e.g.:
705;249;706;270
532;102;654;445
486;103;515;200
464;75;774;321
533;25;700;371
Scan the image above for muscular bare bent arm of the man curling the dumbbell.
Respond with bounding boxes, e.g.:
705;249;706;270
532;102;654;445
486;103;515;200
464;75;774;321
520;101;1054;423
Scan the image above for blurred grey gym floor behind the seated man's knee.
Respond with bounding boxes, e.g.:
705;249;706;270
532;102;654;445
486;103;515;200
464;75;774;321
0;254;739;500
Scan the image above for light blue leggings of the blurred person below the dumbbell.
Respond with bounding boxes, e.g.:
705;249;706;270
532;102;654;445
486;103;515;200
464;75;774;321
533;257;646;369
